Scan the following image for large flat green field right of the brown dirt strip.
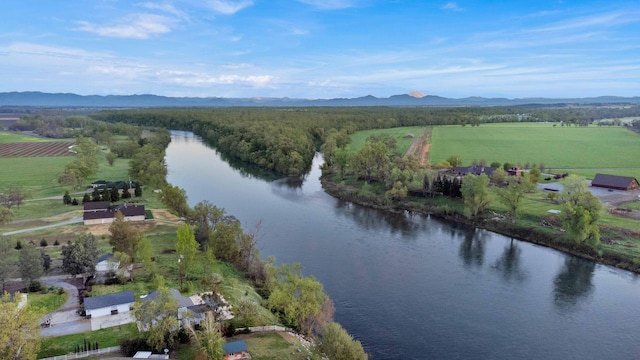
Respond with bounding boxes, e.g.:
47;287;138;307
429;123;640;170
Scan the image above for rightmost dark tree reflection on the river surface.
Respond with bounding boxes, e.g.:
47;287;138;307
553;256;596;310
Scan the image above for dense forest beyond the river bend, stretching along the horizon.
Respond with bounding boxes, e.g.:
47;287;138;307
91;105;640;175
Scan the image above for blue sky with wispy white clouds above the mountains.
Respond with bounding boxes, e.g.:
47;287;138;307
0;0;640;98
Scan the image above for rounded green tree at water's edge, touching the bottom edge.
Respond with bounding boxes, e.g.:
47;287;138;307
318;322;369;360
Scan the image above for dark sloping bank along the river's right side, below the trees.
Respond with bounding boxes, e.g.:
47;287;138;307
320;167;640;274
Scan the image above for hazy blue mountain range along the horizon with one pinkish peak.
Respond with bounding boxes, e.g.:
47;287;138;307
0;91;640;108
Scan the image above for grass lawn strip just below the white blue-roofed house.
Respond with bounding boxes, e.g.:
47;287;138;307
38;324;138;358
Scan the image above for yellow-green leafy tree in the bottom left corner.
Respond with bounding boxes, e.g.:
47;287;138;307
0;292;40;360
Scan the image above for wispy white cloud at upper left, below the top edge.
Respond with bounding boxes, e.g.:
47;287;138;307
76;14;176;39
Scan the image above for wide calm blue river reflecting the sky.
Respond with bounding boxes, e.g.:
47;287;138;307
166;131;640;359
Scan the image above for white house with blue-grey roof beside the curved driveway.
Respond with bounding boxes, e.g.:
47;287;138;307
84;290;135;330
